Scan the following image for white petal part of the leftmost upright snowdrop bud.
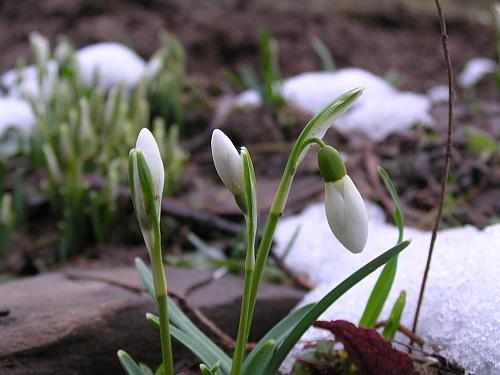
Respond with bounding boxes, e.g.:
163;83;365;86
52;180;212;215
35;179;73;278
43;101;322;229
135;128;165;201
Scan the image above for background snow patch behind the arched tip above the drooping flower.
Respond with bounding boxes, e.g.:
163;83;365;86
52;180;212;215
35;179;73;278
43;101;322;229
237;68;432;141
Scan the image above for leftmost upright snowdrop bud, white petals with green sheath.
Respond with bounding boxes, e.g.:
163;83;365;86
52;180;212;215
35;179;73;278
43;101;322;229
129;128;165;252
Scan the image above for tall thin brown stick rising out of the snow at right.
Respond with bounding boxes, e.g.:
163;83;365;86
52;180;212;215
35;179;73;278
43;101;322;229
412;0;455;333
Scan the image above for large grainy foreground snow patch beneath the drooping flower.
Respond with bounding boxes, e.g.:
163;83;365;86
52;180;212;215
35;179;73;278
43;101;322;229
276;203;500;375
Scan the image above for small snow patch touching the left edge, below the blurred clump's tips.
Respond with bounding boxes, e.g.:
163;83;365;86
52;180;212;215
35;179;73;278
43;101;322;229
0;98;35;136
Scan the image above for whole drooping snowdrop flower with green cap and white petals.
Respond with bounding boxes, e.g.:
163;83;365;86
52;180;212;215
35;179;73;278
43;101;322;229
318;146;368;254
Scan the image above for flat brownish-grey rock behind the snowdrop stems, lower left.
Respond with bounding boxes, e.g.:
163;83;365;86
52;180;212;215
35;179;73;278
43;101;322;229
0;268;303;375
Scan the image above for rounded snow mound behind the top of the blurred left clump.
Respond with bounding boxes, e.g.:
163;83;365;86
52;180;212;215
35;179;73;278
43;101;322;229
76;42;146;89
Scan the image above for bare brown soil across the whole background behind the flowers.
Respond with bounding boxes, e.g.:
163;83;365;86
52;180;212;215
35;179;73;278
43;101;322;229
0;0;500;273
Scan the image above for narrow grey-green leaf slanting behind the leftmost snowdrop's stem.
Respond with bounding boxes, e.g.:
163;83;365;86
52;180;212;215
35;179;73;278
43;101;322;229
135;258;231;373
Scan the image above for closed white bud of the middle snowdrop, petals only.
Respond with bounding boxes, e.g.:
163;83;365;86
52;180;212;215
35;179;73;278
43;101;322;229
211;129;243;196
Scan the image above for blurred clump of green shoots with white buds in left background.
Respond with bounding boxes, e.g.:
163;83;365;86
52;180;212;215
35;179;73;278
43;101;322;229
4;33;188;261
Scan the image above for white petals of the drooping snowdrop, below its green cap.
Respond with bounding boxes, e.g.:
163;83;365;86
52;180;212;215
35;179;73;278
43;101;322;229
325;175;368;254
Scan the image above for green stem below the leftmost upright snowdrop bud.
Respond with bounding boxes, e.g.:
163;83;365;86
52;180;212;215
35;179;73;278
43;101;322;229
151;222;174;375
